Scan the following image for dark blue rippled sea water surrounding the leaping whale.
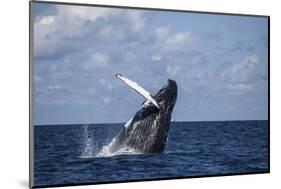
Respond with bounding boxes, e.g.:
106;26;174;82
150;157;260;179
34;121;268;186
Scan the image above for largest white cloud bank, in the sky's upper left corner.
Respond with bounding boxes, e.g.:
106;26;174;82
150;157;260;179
34;5;145;57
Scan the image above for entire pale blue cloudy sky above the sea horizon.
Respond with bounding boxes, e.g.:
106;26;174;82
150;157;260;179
33;3;268;125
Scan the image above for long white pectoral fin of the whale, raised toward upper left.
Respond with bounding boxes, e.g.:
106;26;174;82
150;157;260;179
116;74;160;109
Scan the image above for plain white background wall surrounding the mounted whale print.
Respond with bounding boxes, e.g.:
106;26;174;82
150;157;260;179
0;0;276;189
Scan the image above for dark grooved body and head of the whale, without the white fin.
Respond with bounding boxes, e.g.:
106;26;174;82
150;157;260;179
122;80;177;153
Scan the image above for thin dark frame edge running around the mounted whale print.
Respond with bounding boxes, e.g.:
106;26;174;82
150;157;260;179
29;0;270;188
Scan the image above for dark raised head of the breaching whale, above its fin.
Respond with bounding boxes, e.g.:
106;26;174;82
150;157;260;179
154;79;177;113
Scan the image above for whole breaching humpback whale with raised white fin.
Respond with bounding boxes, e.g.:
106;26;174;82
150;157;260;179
99;74;177;156
